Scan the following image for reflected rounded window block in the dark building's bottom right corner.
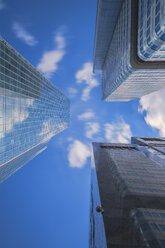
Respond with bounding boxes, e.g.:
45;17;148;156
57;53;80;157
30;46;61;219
130;208;165;248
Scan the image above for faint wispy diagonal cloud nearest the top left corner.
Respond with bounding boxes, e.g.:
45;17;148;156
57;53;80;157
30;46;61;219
13;22;37;46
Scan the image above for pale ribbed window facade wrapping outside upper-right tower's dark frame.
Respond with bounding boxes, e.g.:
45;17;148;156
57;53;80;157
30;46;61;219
102;0;165;101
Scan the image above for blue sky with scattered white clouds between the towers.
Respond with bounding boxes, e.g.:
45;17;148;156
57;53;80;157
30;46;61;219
0;0;165;248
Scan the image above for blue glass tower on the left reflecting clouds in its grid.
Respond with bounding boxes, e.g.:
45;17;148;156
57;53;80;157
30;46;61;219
0;38;69;182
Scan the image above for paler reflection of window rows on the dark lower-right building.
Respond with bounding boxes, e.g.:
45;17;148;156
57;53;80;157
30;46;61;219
102;146;165;196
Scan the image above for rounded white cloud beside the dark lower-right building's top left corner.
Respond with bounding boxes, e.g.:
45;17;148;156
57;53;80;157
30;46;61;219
68;140;91;168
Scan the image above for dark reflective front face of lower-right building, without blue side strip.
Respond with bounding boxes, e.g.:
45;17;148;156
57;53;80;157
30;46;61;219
91;141;165;248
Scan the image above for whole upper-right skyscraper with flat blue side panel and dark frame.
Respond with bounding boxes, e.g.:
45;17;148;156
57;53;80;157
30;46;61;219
94;0;165;101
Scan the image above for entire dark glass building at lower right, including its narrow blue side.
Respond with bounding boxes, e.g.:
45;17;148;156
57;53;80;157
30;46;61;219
89;138;165;248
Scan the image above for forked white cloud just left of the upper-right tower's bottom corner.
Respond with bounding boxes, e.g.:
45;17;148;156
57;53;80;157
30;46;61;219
75;62;99;101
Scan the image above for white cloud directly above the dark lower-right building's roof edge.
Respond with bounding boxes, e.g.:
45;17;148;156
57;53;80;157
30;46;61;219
104;120;132;143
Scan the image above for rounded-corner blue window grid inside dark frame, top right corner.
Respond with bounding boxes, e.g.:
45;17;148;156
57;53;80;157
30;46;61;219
138;0;165;61
